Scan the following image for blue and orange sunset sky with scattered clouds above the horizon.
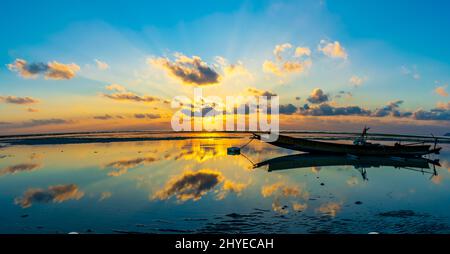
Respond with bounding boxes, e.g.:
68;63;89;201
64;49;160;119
0;0;450;135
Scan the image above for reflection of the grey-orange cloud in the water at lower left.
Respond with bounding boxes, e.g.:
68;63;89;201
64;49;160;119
15;184;84;208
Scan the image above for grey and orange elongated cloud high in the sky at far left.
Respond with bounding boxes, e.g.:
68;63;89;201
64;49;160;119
7;59;80;79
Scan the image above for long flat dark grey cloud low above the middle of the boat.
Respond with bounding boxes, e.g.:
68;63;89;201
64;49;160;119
299;103;371;116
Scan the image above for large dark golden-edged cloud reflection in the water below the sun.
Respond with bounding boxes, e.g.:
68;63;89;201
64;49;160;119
153;169;223;201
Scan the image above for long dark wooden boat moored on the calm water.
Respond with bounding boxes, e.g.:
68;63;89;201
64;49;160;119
253;128;441;157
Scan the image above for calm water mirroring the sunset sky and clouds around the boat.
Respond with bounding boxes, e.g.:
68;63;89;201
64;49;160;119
0;134;450;234
